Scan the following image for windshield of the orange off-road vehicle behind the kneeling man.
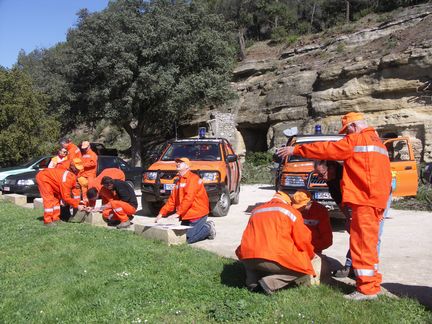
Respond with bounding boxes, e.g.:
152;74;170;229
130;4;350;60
161;142;221;161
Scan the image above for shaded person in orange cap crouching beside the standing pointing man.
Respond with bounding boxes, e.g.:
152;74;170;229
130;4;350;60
292;189;333;254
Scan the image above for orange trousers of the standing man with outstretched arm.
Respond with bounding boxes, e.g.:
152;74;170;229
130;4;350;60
350;205;384;295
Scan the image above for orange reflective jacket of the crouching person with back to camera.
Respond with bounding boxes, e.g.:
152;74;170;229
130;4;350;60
236;198;315;275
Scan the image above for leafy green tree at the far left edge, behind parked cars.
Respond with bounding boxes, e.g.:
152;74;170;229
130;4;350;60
0;69;59;166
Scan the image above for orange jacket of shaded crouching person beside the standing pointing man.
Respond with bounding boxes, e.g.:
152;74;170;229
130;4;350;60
302;201;333;253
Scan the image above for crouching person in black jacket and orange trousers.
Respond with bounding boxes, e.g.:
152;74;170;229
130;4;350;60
98;176;138;229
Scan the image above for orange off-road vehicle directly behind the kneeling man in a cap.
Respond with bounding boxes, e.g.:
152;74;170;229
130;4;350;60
141;138;241;217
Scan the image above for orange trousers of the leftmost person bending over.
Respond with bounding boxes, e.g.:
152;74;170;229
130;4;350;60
36;173;61;224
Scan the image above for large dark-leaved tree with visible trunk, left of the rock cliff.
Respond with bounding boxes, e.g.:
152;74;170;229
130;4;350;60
66;0;234;163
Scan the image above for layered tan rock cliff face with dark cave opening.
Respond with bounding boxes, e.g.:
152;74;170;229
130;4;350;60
183;4;432;161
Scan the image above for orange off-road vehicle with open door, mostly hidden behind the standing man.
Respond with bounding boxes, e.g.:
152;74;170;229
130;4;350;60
276;134;418;217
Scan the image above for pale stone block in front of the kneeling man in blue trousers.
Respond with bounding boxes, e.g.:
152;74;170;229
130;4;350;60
135;224;187;245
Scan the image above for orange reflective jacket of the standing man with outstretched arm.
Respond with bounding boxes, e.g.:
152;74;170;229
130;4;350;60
294;127;391;208
